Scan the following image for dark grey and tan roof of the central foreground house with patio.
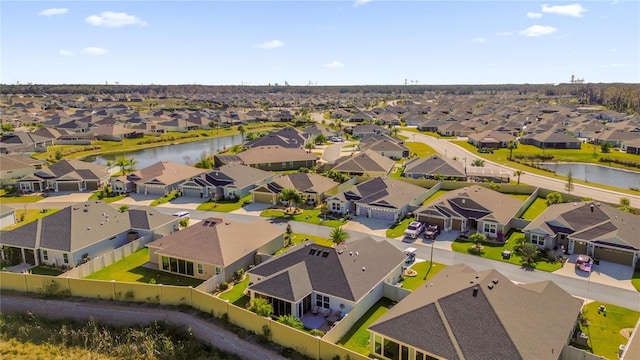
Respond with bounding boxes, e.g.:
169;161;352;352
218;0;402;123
248;237;406;301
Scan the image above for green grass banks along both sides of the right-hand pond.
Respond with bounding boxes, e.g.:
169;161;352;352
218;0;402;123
452;141;638;195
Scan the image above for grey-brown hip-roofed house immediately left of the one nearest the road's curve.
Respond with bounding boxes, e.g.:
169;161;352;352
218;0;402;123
326;150;396;177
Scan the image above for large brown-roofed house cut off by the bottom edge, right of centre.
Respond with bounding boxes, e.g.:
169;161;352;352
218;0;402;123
368;264;582;360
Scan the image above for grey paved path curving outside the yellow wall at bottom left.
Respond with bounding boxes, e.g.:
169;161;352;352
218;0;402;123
0;295;286;360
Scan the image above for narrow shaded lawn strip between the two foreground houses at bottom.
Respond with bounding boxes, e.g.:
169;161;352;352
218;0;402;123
338;298;393;356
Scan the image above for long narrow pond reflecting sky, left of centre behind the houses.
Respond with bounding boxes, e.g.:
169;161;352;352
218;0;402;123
83;134;242;169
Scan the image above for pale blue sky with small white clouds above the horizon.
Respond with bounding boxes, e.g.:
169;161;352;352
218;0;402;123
0;0;640;85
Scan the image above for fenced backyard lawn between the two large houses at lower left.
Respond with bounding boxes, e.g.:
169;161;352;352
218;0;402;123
86;248;202;287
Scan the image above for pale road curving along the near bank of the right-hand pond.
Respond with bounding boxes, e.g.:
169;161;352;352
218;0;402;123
400;131;640;208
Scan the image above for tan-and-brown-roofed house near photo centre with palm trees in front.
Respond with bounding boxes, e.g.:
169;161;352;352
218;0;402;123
251;173;340;205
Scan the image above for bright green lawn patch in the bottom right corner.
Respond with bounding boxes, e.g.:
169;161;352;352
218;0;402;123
580;301;640;359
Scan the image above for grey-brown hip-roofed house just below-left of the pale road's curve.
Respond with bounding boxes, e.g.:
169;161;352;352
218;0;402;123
402;155;467;181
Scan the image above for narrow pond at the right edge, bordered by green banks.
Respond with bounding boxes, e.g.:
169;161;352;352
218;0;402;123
538;163;640;189
